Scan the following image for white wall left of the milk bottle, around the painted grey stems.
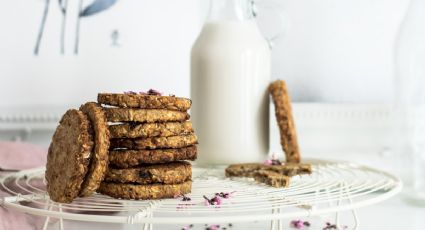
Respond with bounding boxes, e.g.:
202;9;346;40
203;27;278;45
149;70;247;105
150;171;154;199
0;0;201;107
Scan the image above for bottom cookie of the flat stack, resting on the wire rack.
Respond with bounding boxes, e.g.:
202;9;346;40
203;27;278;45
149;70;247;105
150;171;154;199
97;180;192;200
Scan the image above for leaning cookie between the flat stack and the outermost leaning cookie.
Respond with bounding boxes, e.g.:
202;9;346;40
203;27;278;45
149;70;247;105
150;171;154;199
79;102;109;197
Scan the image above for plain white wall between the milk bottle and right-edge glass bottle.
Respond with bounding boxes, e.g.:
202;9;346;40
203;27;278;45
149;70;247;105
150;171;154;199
266;0;408;103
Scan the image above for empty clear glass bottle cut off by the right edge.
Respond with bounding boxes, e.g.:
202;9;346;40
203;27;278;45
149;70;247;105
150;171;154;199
394;0;425;205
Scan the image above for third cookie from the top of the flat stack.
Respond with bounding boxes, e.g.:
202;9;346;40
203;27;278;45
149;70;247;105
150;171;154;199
109;121;193;138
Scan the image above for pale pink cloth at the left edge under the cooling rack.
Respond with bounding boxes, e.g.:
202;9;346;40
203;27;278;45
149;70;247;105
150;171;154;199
0;142;47;230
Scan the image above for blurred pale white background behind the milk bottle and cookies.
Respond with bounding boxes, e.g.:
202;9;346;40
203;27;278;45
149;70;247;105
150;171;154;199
0;0;408;169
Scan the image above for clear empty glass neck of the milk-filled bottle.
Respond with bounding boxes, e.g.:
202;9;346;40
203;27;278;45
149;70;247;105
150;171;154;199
207;0;254;21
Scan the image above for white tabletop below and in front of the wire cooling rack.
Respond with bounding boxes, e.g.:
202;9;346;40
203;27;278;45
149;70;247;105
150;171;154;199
34;195;425;230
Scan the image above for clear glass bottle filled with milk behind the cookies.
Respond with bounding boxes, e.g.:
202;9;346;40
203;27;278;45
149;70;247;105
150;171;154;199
191;0;271;164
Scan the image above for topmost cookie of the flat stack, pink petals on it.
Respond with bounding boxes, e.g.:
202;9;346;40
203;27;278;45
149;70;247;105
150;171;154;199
97;93;192;111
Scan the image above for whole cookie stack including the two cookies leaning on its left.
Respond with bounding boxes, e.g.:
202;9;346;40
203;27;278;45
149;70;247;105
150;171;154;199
46;90;197;203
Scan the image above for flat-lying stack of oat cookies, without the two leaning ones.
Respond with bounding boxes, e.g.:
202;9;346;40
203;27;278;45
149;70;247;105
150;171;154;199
98;90;198;199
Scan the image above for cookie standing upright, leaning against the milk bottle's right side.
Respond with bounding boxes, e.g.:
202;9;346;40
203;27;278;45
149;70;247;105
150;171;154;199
269;80;301;163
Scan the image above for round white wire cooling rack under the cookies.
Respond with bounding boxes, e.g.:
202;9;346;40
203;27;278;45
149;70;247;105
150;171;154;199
0;160;402;229
